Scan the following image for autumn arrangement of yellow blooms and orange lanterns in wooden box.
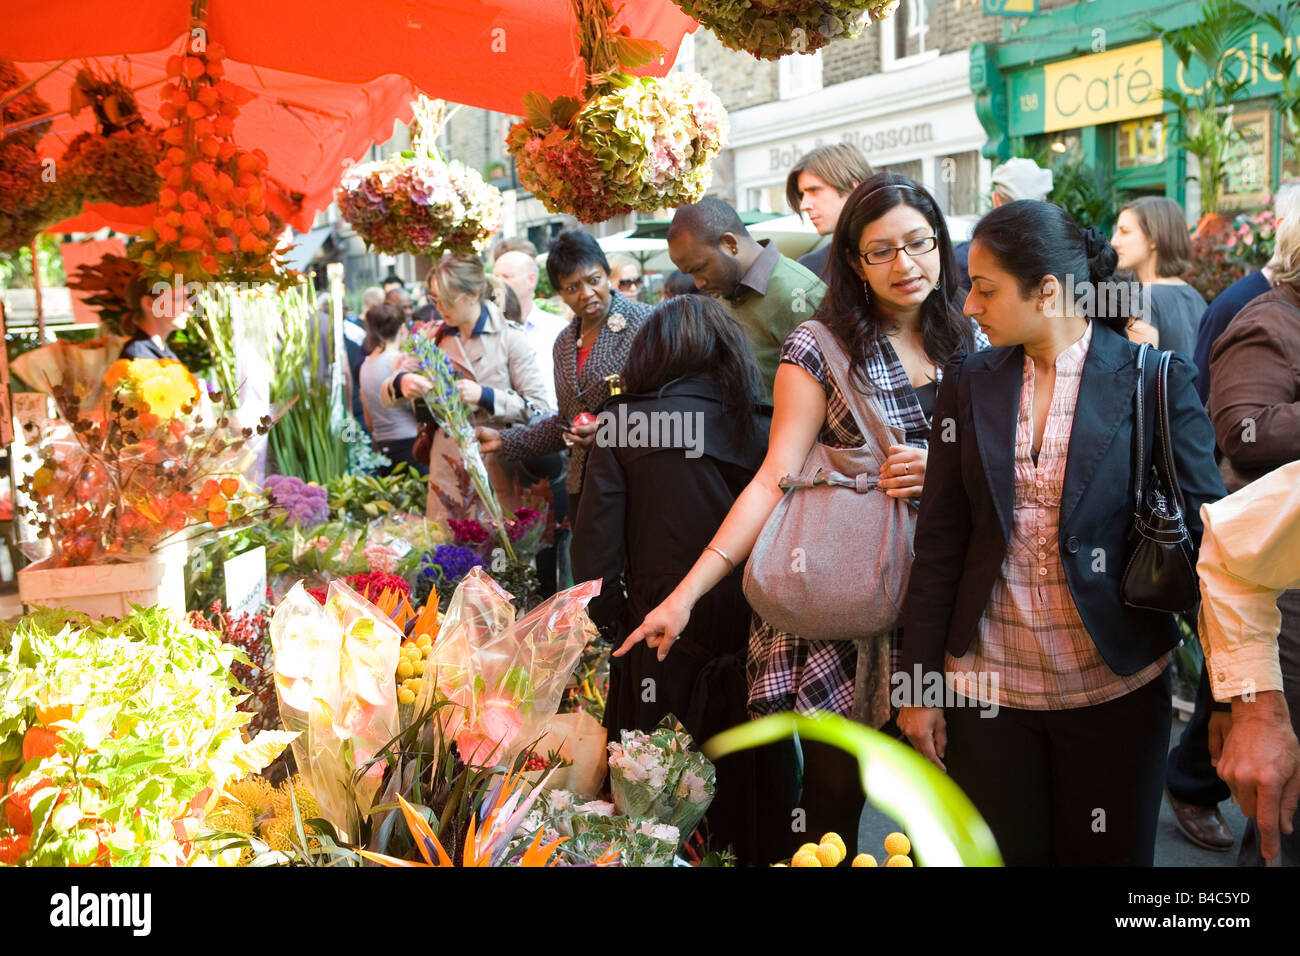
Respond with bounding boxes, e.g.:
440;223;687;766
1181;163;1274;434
23;359;270;567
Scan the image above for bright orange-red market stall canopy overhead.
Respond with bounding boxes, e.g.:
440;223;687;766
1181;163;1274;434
0;0;696;232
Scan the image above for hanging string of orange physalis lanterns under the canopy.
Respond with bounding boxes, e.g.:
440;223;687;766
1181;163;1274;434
131;36;282;282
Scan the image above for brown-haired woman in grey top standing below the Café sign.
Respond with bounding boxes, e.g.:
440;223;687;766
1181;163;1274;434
1110;196;1205;359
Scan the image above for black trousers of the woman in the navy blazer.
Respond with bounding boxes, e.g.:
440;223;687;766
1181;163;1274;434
944;676;1171;866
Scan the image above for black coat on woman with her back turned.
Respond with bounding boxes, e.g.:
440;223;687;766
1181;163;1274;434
572;378;771;741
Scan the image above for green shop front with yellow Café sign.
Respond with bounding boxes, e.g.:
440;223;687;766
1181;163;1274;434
971;0;1300;213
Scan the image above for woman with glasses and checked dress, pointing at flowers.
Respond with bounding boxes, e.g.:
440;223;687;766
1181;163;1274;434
616;173;979;861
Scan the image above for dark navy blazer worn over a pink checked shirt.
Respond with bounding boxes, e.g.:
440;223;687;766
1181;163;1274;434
902;323;1225;675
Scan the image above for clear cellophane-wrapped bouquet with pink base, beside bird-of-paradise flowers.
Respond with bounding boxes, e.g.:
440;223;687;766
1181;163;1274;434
426;567;601;766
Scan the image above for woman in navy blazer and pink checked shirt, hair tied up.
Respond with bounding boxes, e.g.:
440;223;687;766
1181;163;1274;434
898;200;1223;866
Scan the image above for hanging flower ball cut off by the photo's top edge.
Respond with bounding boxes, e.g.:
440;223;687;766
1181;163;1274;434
673;0;900;60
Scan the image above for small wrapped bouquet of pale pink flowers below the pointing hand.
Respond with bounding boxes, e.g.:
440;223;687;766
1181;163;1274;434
610;714;718;835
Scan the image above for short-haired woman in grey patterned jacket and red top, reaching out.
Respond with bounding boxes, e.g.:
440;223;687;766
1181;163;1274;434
476;229;651;530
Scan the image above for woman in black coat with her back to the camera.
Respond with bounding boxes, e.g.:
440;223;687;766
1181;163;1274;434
573;295;772;864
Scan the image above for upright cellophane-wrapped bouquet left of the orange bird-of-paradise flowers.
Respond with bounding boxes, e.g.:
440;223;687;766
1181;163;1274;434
270;581;402;835
